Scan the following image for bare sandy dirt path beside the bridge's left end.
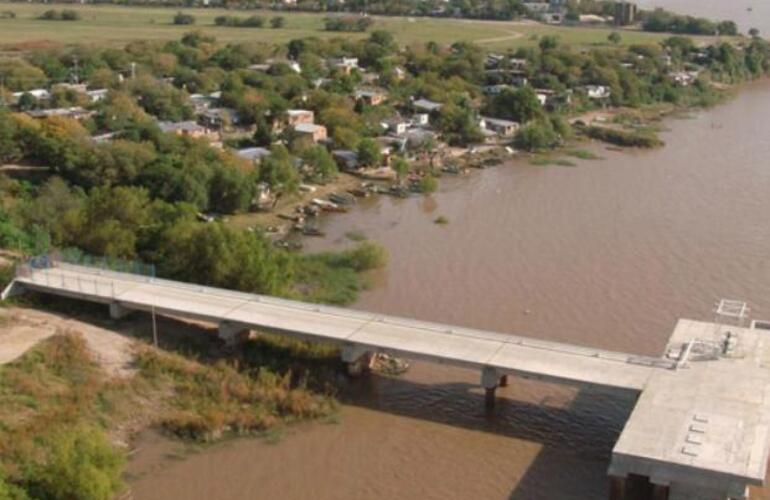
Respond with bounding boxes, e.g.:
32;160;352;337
0;307;135;377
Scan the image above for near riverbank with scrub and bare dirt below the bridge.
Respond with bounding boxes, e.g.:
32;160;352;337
0;301;338;500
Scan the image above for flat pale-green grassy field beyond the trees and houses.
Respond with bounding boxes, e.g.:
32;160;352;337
0;3;708;50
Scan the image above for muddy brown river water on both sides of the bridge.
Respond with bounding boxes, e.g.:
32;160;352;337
130;83;770;500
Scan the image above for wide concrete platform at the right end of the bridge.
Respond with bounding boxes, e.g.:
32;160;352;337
610;320;770;500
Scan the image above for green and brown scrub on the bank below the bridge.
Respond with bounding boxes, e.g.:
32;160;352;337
0;332;335;500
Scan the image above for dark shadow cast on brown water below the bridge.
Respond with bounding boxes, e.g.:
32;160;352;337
340;370;636;500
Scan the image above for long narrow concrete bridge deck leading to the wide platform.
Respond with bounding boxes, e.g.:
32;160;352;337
6;264;673;391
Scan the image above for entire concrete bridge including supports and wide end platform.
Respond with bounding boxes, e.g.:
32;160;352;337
2;261;770;500
